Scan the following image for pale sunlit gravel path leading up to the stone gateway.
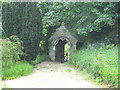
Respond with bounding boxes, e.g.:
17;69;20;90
5;61;106;88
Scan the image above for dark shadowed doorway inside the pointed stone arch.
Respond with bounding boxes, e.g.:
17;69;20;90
55;39;67;63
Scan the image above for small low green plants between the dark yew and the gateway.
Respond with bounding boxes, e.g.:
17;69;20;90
30;55;49;65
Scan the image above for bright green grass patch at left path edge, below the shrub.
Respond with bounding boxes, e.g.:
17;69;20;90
2;62;33;80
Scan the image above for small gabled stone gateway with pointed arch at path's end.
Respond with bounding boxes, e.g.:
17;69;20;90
49;24;82;62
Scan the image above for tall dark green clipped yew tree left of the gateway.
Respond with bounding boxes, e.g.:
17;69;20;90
2;2;42;60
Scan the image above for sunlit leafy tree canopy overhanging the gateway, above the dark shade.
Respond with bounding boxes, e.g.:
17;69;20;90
39;2;118;35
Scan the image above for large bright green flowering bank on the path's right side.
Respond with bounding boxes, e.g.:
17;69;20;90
70;45;118;87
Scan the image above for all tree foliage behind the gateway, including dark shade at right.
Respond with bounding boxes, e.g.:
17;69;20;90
39;2;119;52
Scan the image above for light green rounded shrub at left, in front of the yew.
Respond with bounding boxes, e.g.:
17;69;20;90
2;36;24;67
